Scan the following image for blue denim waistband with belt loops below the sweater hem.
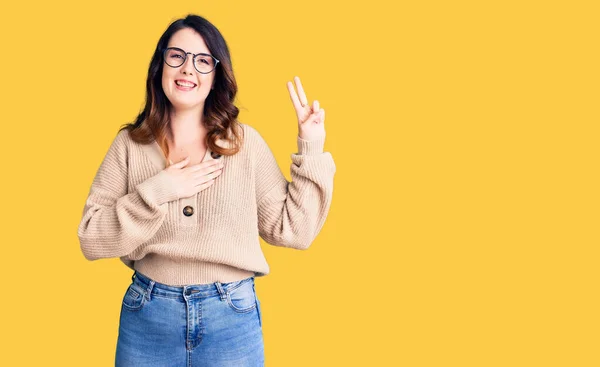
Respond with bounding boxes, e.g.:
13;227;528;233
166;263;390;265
131;270;254;299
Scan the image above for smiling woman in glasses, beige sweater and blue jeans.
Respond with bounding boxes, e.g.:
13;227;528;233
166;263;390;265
78;15;336;366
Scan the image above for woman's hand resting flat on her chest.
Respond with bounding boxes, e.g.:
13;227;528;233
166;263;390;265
165;156;223;198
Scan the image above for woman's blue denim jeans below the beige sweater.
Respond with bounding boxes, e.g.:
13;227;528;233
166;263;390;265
115;271;264;367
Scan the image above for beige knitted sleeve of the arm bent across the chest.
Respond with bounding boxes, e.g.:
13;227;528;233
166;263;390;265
77;130;177;260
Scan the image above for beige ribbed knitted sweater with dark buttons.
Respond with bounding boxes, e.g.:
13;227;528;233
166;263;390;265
77;123;336;285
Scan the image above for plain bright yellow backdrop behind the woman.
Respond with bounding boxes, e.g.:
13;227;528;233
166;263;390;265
0;0;600;367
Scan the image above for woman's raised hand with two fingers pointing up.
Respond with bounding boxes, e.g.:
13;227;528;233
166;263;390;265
287;76;325;140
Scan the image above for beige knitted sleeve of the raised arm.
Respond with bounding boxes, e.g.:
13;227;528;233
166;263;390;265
250;129;336;250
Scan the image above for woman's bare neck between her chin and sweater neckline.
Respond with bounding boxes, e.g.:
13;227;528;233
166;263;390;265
167;108;207;148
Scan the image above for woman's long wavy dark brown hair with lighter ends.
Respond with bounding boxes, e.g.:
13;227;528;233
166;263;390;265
119;14;243;164
